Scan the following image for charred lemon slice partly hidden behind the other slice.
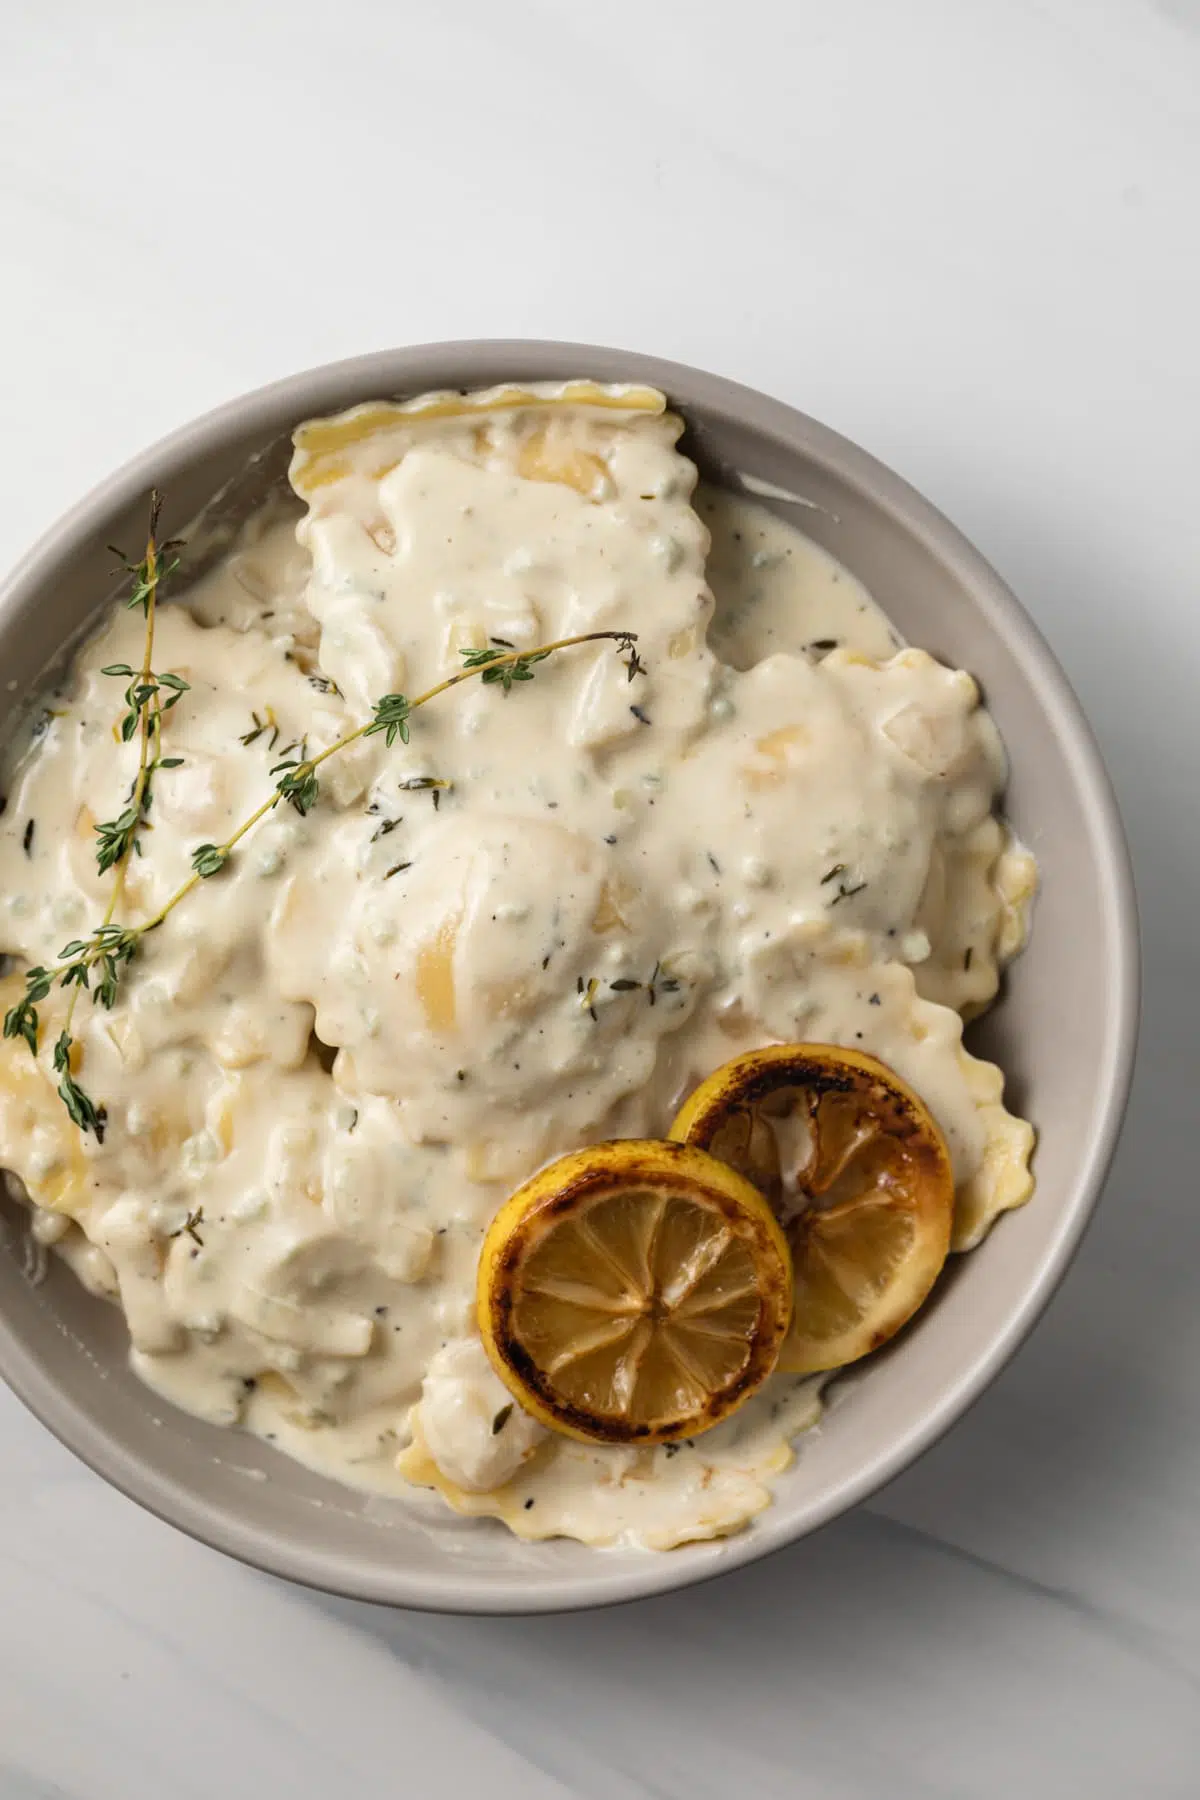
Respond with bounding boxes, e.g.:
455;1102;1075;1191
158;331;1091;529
671;1044;954;1372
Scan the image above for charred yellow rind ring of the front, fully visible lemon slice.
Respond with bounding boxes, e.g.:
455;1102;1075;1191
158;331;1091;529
475;1138;793;1445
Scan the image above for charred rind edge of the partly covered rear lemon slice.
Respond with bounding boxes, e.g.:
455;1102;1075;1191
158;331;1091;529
669;1044;955;1375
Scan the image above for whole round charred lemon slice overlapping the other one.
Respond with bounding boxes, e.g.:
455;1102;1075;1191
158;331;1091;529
477;1138;792;1444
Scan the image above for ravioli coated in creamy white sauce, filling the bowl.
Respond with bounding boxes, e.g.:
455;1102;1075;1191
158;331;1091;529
0;391;1033;1546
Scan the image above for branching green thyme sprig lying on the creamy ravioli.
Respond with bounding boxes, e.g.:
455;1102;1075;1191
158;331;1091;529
4;612;637;1141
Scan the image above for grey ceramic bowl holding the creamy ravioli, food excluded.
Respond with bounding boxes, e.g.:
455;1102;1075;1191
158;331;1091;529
0;342;1137;1613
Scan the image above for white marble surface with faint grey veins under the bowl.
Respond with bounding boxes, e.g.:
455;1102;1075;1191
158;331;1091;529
0;0;1200;1800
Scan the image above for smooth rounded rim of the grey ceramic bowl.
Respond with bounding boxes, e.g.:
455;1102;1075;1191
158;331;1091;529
0;338;1141;1615
